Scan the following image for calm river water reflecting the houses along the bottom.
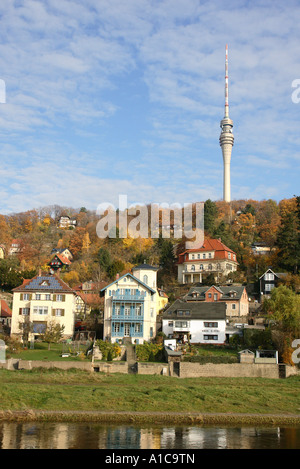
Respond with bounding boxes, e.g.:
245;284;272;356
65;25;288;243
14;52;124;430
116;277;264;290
0;422;300;450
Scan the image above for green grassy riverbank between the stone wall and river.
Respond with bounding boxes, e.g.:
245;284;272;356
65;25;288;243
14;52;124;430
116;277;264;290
0;369;300;423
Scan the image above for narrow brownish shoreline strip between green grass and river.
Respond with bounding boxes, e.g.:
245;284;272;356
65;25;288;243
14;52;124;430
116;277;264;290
0;409;300;426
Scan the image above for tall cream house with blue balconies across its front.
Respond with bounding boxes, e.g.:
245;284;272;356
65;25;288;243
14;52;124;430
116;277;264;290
101;264;160;344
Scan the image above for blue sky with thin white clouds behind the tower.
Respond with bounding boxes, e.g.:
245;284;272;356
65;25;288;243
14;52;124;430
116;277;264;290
0;0;300;214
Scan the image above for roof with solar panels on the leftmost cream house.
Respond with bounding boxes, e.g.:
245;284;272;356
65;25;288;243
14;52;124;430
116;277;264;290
12;275;75;294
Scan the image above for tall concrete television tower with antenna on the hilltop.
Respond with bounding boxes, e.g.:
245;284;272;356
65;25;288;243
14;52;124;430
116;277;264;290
220;44;234;202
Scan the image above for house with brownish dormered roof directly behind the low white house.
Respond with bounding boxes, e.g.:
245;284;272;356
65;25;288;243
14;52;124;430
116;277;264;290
184;285;249;320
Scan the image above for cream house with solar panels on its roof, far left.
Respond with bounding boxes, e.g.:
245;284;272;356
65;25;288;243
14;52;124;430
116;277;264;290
11;275;76;338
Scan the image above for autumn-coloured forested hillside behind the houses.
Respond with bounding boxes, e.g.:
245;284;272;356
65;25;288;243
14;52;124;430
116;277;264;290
0;196;300;292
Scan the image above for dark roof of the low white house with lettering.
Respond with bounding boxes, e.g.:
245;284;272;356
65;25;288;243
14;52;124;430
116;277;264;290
163;299;226;320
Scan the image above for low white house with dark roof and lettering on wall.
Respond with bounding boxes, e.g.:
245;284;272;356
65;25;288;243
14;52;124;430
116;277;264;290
162;299;226;344
